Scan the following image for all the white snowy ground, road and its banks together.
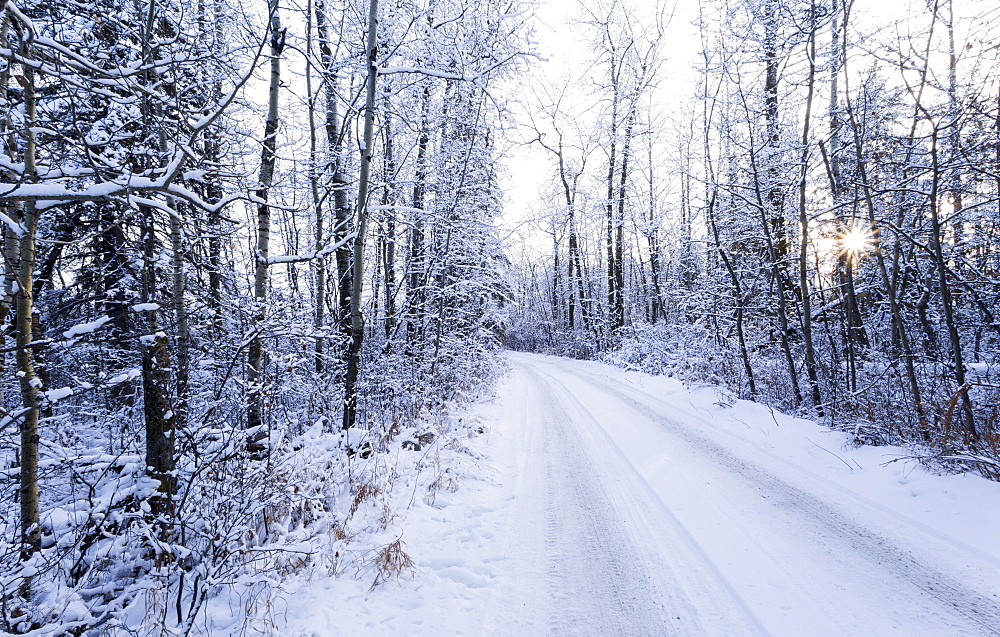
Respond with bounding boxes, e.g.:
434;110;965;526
271;354;1000;636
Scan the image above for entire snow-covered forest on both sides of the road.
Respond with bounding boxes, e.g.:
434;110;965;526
0;0;1000;635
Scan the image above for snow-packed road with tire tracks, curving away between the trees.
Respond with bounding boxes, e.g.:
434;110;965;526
485;355;1000;635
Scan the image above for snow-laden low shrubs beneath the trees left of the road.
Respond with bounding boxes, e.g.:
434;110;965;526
0;320;502;635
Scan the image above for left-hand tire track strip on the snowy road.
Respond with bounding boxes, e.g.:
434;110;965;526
519;366;764;635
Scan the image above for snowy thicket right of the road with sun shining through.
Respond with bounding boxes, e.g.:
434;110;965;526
508;0;1000;477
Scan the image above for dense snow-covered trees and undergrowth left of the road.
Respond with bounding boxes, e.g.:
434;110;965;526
0;0;524;634
